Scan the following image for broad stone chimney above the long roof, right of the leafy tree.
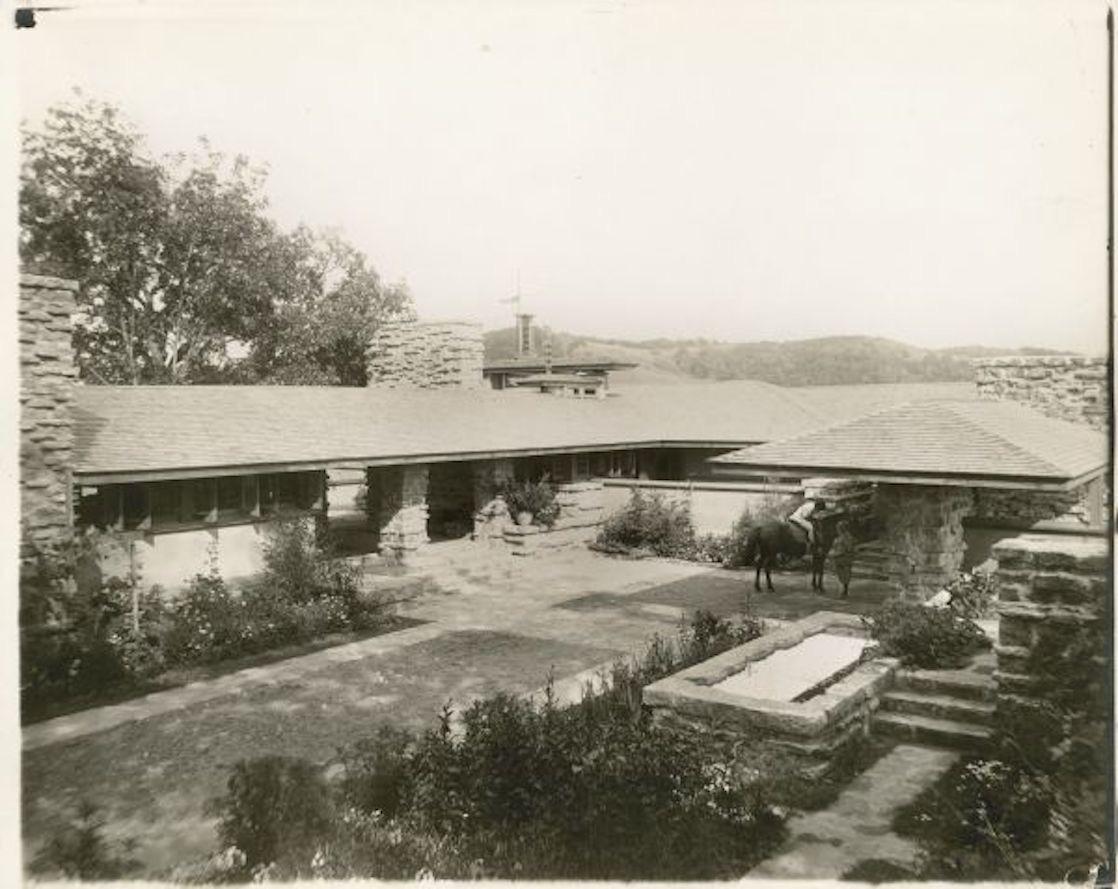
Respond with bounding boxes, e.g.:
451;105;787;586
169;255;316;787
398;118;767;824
368;321;484;389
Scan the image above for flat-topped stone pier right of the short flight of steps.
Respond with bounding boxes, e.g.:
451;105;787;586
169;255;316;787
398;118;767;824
994;535;1110;742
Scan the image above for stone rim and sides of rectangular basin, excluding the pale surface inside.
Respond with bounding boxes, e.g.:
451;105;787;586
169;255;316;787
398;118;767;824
643;612;897;774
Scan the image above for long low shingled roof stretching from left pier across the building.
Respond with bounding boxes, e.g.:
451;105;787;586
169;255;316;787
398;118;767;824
74;380;979;483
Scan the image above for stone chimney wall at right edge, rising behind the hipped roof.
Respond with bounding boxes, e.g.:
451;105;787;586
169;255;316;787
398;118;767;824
974;356;1110;432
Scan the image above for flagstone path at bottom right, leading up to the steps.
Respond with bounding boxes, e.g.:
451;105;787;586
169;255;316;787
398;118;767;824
748;744;959;880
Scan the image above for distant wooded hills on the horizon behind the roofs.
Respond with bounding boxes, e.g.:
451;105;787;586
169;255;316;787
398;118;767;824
485;328;1063;386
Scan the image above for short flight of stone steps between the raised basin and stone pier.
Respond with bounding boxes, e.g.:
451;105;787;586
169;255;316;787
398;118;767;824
873;670;996;753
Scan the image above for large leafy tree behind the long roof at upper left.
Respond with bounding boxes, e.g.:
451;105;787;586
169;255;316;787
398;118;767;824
20;94;410;385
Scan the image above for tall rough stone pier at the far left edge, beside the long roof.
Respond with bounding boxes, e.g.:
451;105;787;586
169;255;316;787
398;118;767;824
19;275;77;556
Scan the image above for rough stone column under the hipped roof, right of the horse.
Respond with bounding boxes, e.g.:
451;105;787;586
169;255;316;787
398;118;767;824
875;484;974;600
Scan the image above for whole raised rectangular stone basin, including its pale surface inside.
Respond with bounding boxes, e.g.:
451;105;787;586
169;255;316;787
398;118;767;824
643;612;897;760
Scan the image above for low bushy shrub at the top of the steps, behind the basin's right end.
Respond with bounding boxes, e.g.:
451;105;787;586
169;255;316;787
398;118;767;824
862;602;992;670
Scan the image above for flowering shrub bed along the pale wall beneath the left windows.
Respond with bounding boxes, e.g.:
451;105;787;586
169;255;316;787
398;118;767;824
20;520;385;712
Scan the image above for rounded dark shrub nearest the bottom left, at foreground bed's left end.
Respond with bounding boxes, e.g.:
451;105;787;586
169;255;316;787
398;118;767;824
211;756;333;868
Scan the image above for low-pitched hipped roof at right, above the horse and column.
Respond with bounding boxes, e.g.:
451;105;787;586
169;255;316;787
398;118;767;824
711;399;1107;488
